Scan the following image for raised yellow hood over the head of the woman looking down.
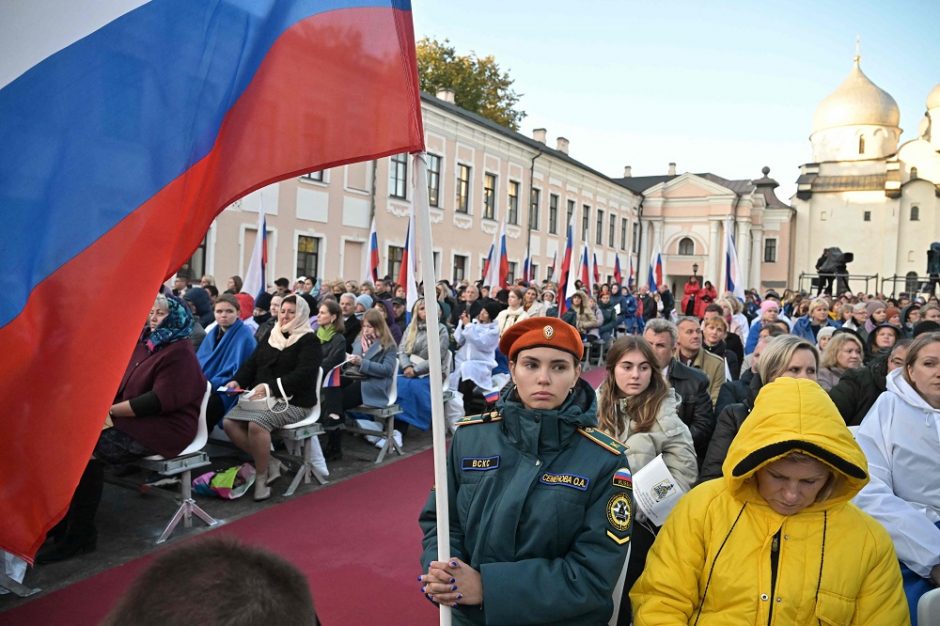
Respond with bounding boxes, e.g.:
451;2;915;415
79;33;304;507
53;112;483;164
721;378;868;507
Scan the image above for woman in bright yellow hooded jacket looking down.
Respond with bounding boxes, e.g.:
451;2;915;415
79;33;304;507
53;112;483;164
630;378;910;626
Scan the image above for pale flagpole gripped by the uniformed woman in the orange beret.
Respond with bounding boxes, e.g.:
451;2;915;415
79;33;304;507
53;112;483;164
413;154;452;626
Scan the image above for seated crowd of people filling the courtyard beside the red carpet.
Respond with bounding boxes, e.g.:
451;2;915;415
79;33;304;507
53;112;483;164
31;268;940;624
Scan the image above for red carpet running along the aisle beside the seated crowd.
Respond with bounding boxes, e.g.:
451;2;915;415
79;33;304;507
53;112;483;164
0;450;438;626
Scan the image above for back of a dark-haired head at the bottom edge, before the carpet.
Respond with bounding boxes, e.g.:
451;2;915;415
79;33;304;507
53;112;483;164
102;537;318;626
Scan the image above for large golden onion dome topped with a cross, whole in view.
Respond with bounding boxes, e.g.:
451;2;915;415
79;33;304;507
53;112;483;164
813;57;900;133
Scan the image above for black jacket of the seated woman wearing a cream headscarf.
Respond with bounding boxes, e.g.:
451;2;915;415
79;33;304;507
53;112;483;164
235;333;323;408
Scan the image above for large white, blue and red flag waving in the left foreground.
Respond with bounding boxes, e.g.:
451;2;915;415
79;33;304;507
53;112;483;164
0;0;423;559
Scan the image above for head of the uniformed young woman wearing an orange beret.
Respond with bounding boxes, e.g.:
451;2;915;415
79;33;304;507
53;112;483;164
499;317;584;409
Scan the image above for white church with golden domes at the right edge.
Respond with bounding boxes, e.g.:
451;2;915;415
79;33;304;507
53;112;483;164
791;57;940;294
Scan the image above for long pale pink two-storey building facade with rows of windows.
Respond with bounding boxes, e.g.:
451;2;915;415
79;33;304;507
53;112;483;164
180;92;641;285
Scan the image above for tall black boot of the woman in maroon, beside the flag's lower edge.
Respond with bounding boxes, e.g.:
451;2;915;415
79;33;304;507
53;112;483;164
36;459;104;564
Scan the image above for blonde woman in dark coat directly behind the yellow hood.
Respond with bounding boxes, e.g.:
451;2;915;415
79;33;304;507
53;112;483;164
698;335;819;483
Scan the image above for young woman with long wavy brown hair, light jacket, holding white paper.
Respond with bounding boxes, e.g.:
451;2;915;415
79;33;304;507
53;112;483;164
597;335;698;625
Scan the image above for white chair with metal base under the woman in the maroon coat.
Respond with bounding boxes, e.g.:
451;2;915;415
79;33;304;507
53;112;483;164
136;382;219;543
